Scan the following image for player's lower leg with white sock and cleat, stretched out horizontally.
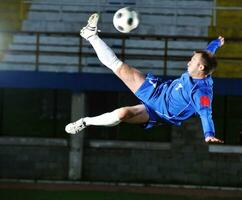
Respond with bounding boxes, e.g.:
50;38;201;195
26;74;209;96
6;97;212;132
65;104;149;134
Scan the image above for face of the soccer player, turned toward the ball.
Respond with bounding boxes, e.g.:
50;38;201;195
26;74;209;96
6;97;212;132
187;53;204;77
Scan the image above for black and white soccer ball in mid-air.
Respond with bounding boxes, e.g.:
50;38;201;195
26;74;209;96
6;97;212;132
113;7;139;33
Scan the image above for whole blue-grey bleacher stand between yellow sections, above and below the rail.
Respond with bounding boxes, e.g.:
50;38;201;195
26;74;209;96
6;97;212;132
0;0;212;75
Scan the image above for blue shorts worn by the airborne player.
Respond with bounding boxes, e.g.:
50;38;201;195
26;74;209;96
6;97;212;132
135;74;168;129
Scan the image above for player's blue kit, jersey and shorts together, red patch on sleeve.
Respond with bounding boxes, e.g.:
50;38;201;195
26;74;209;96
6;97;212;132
135;40;220;138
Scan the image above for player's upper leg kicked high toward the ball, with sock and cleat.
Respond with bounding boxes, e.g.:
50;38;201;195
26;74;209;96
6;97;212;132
80;13;145;93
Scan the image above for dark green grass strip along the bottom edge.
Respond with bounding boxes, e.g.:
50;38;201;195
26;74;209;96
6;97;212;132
0;189;242;200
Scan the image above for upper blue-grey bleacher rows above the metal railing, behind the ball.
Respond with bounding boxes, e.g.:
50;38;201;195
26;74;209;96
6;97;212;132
23;0;212;36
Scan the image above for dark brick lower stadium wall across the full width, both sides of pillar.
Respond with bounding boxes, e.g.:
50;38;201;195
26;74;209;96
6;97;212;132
0;118;242;187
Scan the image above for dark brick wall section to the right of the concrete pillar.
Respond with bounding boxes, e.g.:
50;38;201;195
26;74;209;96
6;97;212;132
83;119;242;186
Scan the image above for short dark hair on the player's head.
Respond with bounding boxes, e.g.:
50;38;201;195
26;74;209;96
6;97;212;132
195;50;217;75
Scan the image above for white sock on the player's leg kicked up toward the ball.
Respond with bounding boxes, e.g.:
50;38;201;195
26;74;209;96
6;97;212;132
88;35;123;72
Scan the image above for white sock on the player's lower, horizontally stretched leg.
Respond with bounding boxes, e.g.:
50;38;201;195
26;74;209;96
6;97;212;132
83;111;121;126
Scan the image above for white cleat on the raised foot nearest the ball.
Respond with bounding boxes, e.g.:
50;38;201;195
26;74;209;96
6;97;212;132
80;13;99;40
